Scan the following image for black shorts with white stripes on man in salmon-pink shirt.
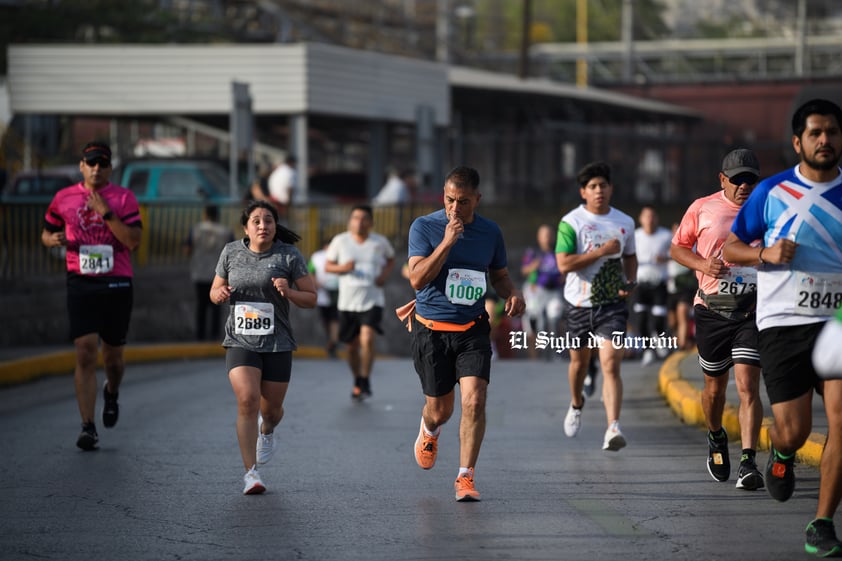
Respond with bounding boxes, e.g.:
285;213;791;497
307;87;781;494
693;304;760;377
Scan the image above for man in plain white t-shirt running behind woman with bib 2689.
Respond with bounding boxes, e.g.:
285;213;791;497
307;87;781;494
325;205;395;401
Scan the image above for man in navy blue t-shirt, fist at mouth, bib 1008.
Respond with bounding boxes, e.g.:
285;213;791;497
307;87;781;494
408;166;525;501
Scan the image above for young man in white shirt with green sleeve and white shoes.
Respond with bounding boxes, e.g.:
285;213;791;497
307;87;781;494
555;162;637;451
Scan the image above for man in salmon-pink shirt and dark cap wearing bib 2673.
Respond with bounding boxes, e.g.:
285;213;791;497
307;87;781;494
670;148;764;490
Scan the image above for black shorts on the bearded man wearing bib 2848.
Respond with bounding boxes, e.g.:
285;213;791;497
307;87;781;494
758;322;824;404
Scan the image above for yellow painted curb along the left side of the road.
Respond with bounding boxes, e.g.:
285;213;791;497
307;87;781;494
0;343;334;385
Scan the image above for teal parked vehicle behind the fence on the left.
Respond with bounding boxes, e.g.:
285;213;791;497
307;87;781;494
111;158;238;203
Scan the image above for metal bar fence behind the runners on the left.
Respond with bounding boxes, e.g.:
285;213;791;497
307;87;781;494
0;204;437;280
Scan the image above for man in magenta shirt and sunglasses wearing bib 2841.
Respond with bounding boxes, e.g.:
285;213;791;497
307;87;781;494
41;142;141;450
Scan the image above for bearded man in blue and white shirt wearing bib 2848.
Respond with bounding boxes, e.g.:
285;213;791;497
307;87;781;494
723;99;842;557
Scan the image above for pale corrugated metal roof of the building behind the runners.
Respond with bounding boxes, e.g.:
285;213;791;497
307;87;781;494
8;43;702;126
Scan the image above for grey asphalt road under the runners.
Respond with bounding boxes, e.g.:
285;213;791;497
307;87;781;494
0;358;818;561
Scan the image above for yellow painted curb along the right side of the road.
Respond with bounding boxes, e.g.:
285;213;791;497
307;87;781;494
658;351;827;467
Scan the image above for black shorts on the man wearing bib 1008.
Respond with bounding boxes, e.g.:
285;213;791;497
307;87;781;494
411;314;491;397
